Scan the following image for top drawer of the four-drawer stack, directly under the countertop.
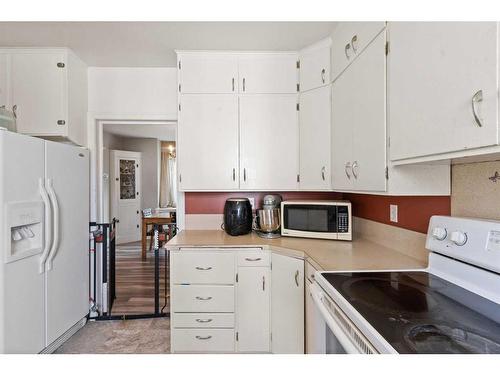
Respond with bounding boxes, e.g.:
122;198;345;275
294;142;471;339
170;250;235;284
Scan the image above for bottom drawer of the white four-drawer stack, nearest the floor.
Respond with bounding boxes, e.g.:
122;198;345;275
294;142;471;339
171;328;234;353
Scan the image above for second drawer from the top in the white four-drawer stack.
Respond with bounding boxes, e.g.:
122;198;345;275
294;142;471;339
172;285;234;313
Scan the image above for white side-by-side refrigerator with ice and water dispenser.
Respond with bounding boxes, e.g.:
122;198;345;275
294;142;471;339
0;130;89;353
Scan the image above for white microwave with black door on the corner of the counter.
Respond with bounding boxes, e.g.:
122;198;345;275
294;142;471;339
281;201;352;241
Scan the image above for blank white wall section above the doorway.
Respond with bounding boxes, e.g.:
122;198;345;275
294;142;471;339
88;67;177;120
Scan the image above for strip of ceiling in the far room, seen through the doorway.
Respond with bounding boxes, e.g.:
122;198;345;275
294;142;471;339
103;123;176;141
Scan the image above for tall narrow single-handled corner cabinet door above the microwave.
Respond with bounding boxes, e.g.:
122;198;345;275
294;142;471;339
299;85;331;190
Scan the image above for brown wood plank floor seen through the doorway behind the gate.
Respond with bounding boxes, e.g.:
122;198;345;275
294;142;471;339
111;242;169;315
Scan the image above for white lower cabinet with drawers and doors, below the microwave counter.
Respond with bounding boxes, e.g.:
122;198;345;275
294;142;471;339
170;247;304;353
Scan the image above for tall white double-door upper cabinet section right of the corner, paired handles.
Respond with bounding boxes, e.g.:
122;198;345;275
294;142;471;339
332;33;386;192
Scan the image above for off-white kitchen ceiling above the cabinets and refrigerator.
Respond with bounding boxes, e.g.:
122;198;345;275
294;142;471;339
0;22;335;67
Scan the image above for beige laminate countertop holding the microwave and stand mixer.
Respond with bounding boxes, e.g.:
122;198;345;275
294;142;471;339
165;230;427;271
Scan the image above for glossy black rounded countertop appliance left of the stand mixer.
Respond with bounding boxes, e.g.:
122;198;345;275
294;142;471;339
223;198;253;236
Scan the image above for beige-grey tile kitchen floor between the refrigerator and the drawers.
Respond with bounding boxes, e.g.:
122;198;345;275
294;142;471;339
55;318;170;354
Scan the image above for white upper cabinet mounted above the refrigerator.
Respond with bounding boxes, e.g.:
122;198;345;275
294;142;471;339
0;49;88;146
